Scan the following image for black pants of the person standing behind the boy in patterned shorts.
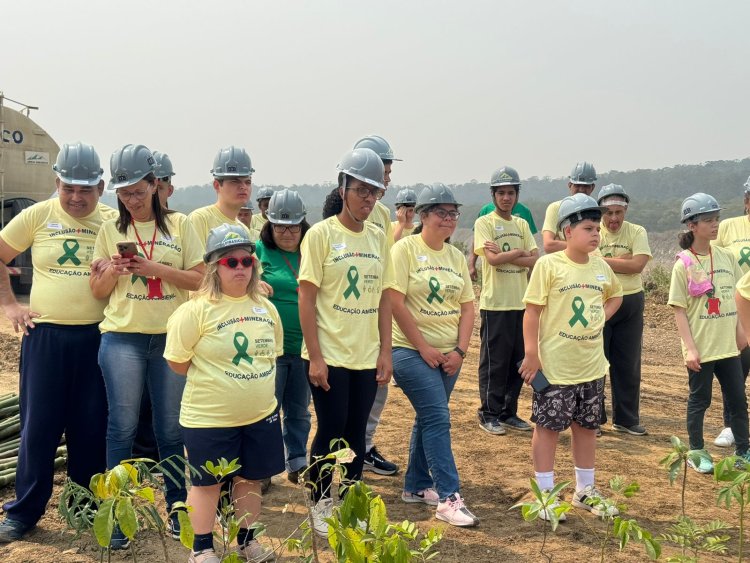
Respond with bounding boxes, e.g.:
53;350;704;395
602;291;645;426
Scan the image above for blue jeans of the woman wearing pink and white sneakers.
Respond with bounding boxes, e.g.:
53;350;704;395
393;348;459;500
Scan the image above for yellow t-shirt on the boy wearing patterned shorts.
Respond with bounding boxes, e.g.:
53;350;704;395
523;252;622;385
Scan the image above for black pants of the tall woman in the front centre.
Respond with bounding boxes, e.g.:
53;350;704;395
304;366;378;502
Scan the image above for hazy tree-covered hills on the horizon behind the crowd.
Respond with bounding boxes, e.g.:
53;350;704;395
105;158;750;233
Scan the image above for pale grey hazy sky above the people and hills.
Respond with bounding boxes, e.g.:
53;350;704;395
0;0;750;186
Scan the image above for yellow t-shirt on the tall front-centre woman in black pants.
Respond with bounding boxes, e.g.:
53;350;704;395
299;216;393;370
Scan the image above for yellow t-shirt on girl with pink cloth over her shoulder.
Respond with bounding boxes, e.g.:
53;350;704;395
668;247;742;362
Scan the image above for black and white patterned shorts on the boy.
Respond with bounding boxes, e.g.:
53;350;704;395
531;377;604;432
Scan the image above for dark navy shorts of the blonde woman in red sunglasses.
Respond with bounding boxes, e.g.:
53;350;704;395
182;410;284;487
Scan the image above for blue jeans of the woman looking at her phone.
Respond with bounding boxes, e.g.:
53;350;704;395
99;332;187;507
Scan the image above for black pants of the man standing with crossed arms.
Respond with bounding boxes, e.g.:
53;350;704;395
477;309;524;422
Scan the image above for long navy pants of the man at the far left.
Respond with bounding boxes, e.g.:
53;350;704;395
3;323;107;526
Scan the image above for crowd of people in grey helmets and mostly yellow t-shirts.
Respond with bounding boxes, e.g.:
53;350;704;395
0;135;750;563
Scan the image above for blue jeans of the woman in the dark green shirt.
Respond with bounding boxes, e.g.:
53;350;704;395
276;354;310;471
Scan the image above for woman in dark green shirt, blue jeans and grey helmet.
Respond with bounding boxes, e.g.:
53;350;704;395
255;190;310;483
